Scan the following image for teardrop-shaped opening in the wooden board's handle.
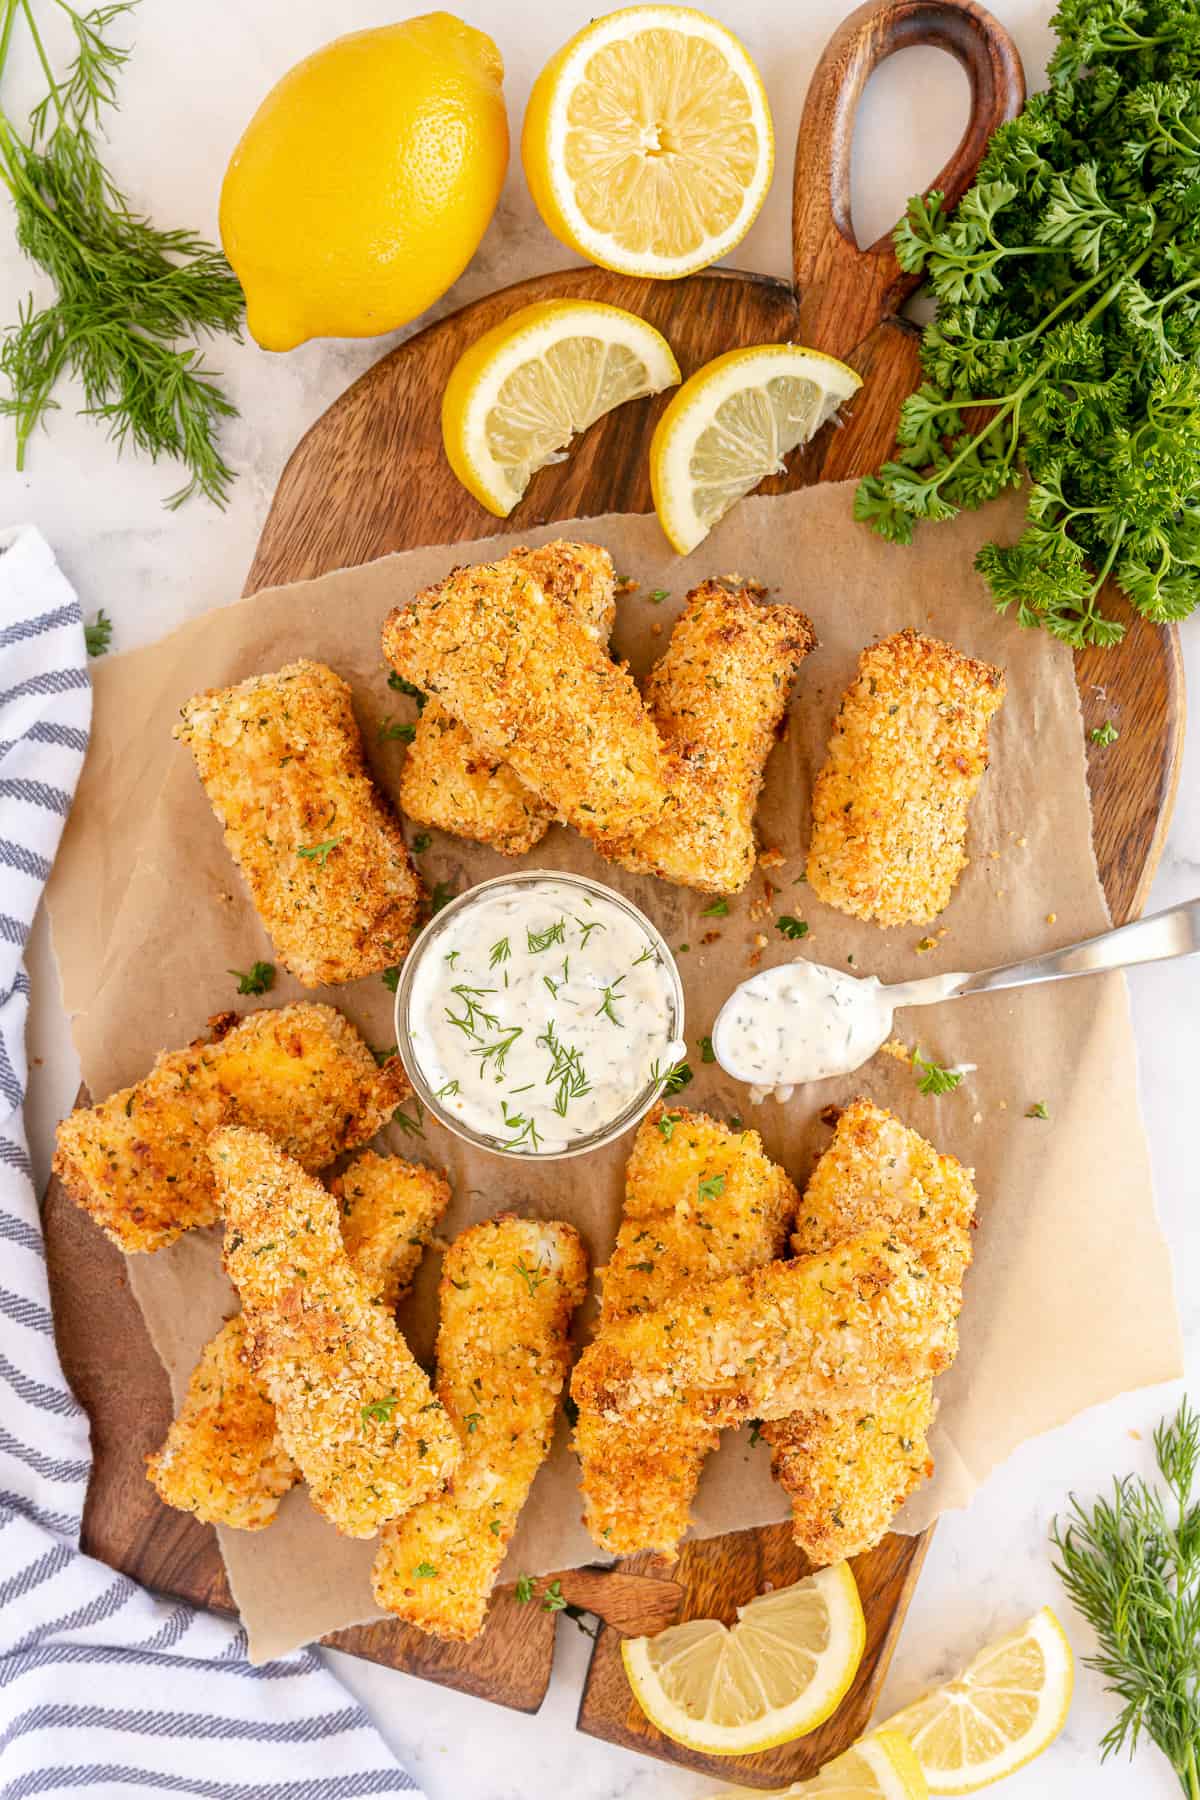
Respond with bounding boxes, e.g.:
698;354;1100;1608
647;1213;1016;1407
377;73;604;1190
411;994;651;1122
849;45;972;248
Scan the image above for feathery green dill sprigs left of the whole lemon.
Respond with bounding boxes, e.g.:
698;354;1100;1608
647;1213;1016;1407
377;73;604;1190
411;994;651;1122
0;0;243;508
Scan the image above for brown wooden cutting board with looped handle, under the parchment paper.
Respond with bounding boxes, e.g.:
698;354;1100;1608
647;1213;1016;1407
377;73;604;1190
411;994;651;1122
45;0;1184;1787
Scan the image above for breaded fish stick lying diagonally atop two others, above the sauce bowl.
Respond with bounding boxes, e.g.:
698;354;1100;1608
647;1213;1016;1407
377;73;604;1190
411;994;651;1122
383;560;667;848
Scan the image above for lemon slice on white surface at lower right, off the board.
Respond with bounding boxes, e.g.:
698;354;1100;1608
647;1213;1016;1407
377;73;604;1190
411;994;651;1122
885;1606;1074;1795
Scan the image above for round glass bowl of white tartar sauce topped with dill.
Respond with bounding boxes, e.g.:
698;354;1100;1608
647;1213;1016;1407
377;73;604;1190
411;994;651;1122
396;869;685;1161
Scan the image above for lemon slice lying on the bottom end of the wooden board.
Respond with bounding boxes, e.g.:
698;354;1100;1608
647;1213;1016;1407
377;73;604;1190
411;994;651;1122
621;1562;867;1757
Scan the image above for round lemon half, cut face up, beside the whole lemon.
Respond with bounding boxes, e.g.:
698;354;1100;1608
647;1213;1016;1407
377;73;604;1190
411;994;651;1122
522;5;775;277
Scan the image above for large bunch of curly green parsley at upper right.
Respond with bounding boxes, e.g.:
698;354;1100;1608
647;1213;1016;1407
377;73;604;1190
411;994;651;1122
855;0;1200;646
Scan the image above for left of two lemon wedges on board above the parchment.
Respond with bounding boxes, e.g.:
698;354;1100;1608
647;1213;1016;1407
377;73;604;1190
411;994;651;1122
441;301;680;518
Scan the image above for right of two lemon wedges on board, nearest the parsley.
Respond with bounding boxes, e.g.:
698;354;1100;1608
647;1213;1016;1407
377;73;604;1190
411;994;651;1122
649;344;862;556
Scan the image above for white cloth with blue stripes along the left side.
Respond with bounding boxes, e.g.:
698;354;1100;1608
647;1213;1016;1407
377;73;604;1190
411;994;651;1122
0;527;426;1800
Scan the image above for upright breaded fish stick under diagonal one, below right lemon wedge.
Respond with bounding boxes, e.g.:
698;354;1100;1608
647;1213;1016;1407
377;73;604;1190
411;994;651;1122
622;581;817;895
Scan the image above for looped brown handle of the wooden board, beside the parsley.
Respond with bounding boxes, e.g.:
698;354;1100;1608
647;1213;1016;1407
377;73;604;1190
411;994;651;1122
792;0;1025;356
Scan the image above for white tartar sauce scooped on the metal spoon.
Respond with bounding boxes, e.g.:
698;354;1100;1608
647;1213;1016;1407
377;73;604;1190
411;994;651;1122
712;958;963;1103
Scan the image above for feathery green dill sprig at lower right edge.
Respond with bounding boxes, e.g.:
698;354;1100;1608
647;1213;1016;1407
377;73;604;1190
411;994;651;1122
1051;1399;1200;1800
